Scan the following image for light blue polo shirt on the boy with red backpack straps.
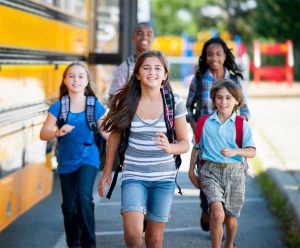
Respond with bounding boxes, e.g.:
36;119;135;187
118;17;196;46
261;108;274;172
200;111;255;163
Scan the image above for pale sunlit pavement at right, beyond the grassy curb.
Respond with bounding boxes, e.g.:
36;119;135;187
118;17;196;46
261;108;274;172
249;97;300;228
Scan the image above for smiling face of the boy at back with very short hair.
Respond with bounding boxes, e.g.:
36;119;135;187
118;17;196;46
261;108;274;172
133;24;154;53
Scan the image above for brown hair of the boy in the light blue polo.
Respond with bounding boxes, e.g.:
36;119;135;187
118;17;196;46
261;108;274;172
210;79;244;112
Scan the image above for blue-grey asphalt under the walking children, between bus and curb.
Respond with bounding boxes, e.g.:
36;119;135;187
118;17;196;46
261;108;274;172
0;127;285;248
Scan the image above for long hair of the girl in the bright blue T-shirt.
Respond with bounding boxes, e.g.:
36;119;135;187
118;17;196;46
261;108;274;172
59;61;95;98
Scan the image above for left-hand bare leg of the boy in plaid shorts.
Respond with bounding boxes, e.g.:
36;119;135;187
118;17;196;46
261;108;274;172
210;202;225;248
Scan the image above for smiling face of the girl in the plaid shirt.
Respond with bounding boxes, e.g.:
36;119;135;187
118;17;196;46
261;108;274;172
206;43;226;71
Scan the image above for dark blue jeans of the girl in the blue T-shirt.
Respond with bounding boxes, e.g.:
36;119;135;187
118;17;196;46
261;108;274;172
60;165;98;248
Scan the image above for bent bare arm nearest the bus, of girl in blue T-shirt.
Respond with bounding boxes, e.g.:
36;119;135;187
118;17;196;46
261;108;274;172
40;113;74;141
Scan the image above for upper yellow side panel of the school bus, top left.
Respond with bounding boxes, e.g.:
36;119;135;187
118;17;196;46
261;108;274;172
0;5;88;55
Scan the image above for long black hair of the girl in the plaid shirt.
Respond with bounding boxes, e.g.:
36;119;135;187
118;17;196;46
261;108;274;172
195;37;243;78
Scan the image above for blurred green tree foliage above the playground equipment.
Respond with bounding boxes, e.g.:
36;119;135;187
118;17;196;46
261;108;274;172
151;0;300;79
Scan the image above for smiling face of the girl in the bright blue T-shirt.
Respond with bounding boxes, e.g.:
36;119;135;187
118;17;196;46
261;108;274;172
64;65;88;93
